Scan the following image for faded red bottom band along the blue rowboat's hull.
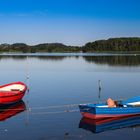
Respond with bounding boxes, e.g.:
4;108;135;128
81;112;140;119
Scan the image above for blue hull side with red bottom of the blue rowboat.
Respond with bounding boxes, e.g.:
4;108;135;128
79;105;140;119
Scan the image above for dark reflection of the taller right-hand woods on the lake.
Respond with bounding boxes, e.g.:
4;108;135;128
83;56;140;66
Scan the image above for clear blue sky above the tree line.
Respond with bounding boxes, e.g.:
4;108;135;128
0;0;140;45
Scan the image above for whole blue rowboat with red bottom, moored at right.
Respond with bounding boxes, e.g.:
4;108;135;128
79;96;140;119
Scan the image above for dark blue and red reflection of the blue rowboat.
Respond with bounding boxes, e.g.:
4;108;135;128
79;115;140;133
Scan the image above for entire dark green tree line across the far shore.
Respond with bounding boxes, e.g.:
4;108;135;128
0;37;140;53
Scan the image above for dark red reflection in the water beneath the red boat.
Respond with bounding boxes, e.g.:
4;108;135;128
0;101;26;121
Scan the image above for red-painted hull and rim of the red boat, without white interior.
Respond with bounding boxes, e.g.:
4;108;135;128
0;82;27;104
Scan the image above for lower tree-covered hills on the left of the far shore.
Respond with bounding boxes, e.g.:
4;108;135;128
0;43;80;53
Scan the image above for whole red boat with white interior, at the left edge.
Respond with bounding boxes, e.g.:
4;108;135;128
0;82;27;104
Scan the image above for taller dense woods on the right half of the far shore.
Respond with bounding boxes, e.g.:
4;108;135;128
82;37;140;52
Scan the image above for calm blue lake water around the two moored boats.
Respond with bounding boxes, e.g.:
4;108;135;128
0;54;140;140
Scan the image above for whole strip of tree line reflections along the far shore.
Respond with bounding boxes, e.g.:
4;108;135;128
0;54;140;66
